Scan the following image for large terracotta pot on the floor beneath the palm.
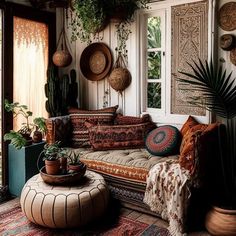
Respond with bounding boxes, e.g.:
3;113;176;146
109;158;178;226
205;207;236;235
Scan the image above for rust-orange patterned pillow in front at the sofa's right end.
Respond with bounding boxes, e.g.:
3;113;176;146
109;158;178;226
179;123;219;174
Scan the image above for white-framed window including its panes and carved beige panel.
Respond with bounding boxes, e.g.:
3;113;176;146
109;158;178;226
138;0;214;126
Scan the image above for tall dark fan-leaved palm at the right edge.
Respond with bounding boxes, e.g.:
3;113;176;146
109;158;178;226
179;59;236;209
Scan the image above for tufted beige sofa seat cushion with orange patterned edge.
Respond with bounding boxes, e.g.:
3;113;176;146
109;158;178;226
68;148;178;185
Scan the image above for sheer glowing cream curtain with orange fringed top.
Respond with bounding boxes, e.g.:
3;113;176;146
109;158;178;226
13;17;48;130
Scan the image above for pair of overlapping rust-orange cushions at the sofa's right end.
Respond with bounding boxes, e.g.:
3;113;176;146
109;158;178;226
179;116;220;174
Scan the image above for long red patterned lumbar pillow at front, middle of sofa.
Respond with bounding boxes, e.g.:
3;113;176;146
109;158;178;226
85;122;156;150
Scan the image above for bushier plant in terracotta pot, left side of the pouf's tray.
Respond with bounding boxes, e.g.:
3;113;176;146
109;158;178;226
39;142;62;175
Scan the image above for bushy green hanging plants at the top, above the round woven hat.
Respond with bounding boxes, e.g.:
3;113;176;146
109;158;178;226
70;0;148;44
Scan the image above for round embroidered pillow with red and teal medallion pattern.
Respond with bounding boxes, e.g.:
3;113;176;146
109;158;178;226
145;125;181;156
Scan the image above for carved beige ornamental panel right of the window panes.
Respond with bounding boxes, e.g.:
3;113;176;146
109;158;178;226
171;0;208;116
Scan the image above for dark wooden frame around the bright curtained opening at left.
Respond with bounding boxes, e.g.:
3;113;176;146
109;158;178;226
0;2;56;186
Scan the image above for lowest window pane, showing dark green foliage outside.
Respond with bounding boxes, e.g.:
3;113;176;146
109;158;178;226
147;83;161;109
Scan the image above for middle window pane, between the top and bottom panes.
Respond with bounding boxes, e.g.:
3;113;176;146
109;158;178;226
147;52;161;79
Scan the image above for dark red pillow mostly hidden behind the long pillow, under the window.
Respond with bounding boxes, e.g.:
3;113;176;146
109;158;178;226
114;114;151;125
